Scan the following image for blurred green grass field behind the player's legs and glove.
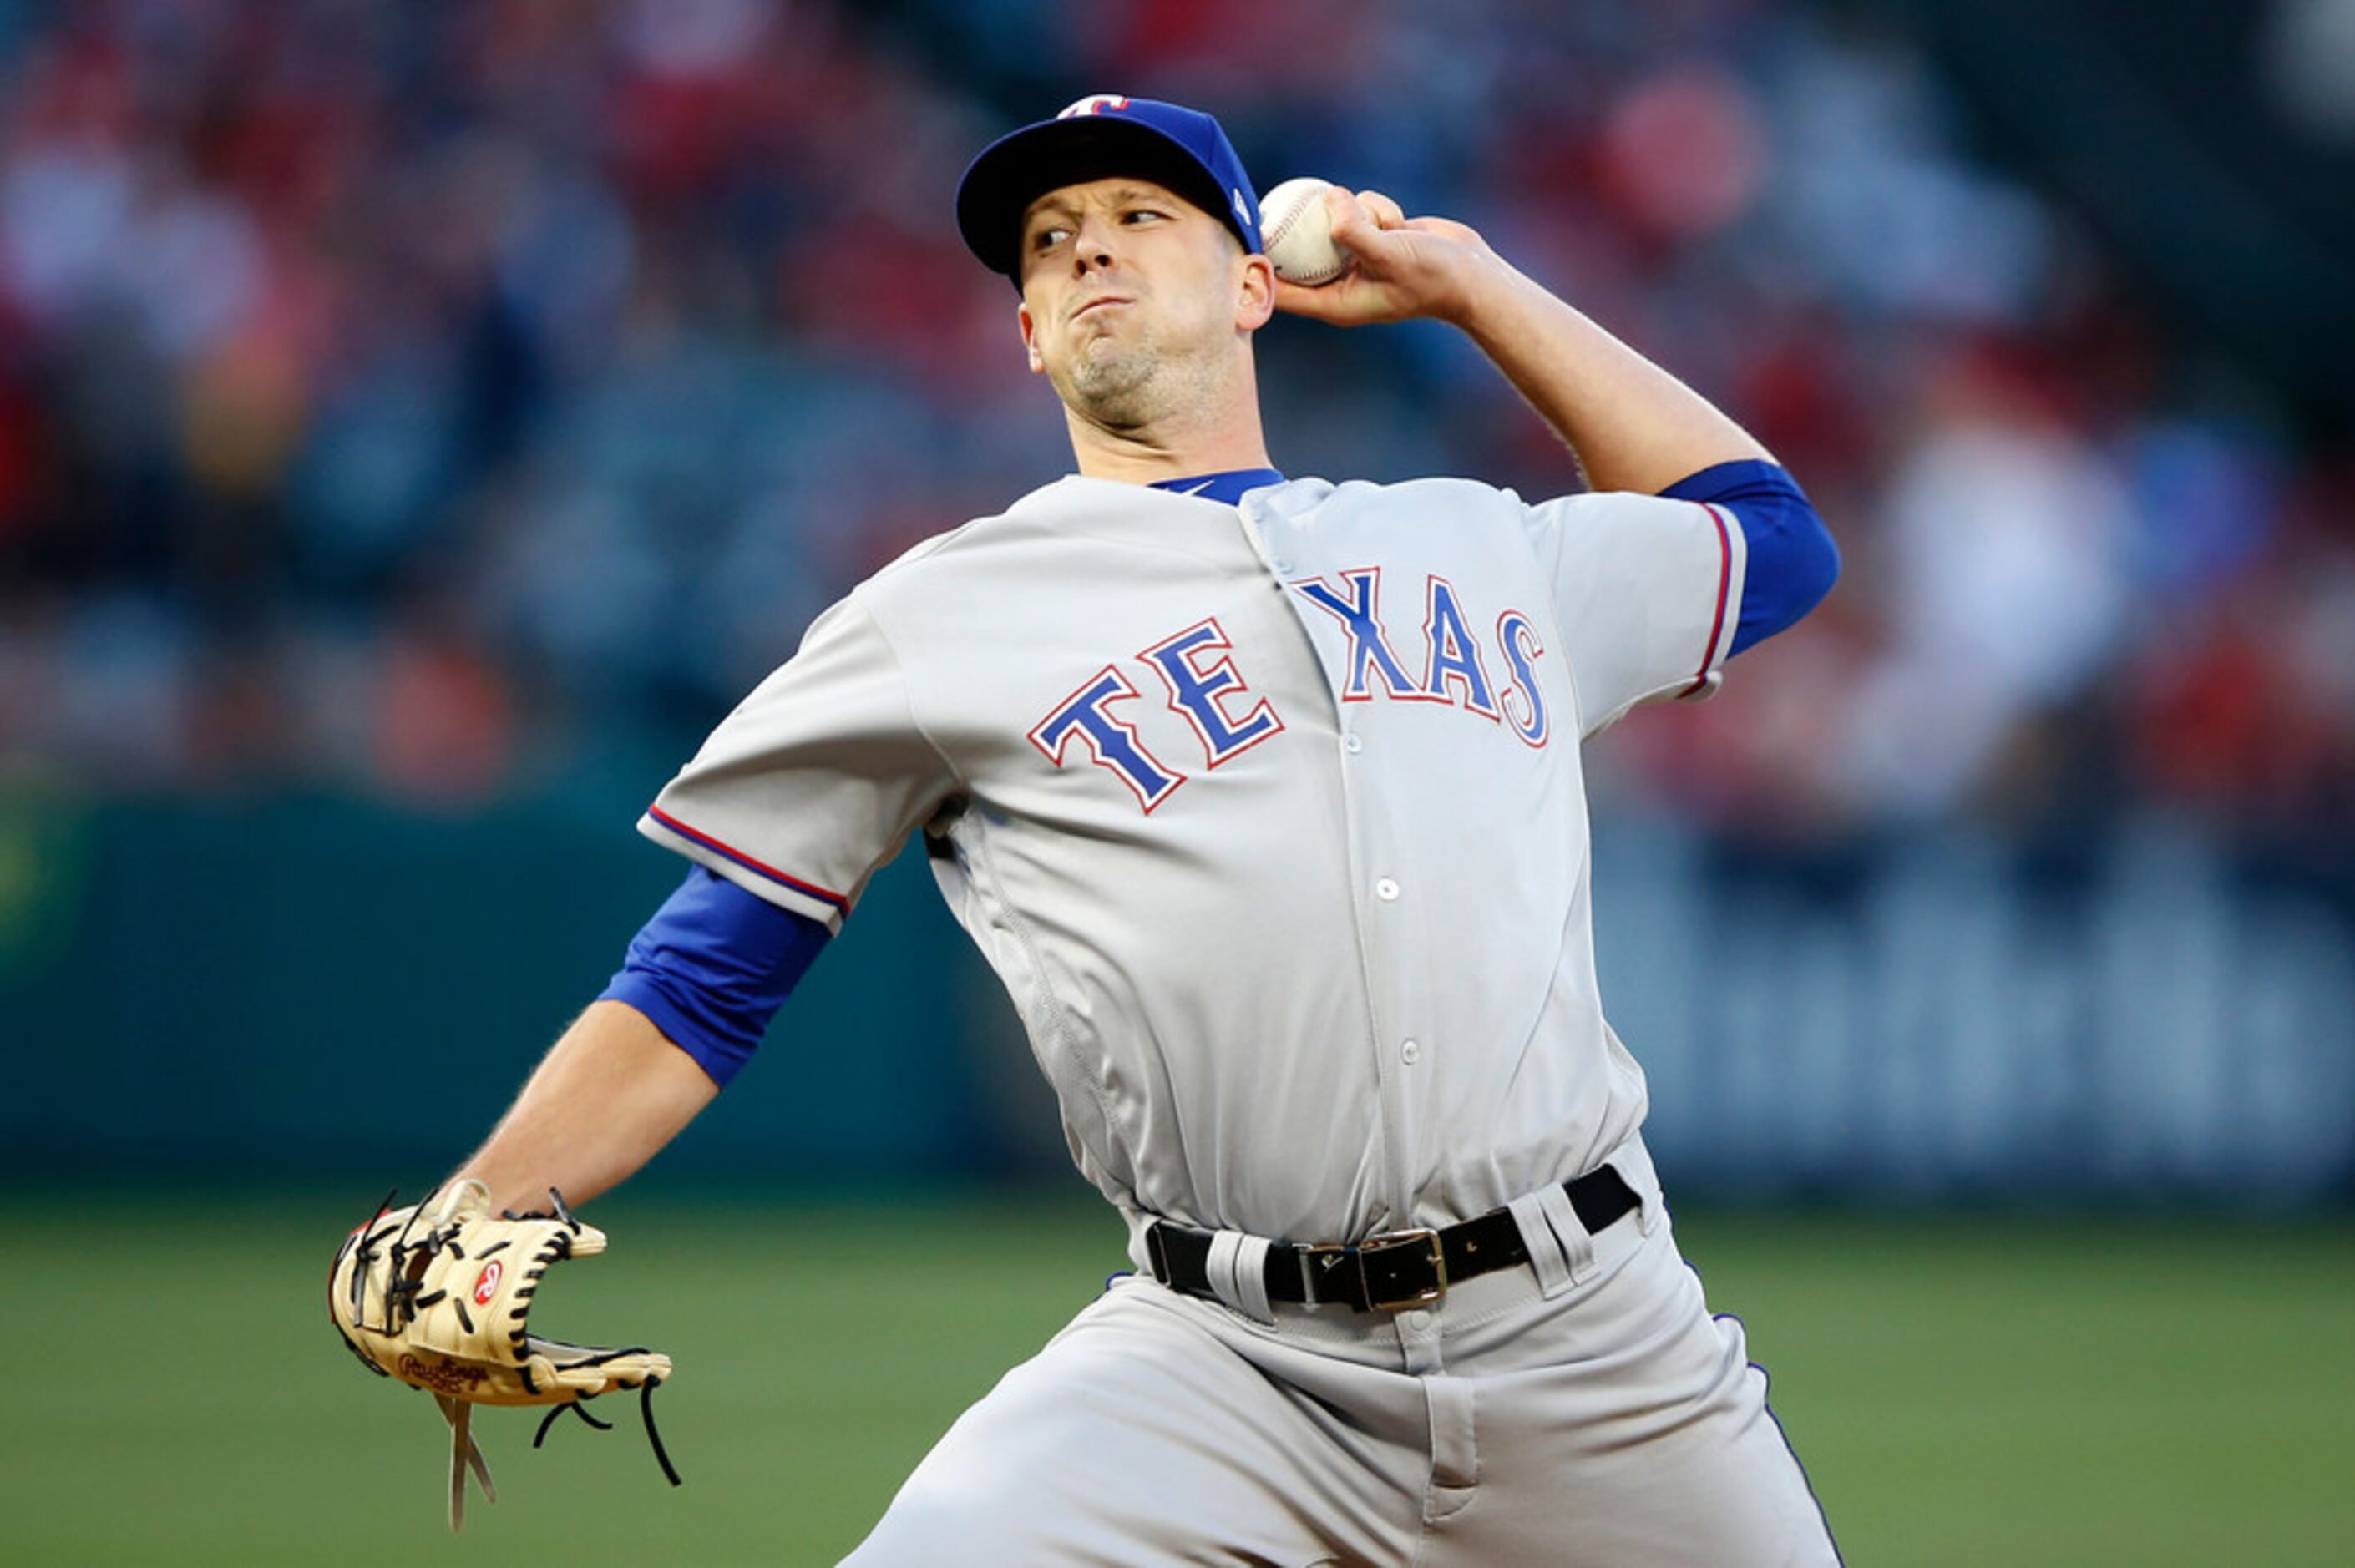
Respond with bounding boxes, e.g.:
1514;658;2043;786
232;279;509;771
0;1191;2355;1568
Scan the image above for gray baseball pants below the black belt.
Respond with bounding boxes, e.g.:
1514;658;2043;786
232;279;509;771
848;1149;1839;1568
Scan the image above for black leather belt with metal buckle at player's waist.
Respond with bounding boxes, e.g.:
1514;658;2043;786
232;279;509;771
1145;1166;1639;1312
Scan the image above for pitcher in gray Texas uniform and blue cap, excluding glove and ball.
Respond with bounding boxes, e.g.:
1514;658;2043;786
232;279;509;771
433;97;1837;1568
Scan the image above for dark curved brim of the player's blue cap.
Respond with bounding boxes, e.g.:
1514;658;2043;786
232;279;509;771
956;115;1248;278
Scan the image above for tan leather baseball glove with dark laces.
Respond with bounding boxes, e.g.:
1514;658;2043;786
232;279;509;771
327;1180;678;1530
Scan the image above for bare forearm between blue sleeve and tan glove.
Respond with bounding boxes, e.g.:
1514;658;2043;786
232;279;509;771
454;1000;718;1210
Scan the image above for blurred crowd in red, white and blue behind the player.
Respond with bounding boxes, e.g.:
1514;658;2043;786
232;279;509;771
0;0;2355;1191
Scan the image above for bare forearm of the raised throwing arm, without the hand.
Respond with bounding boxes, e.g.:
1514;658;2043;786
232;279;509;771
1458;256;1773;494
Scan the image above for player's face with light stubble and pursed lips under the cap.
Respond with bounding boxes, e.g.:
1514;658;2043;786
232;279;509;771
1022;176;1274;428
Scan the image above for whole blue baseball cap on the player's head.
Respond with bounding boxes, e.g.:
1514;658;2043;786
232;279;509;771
956;92;1263;282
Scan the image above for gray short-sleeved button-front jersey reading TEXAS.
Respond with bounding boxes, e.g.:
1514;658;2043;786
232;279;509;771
641;478;1743;1241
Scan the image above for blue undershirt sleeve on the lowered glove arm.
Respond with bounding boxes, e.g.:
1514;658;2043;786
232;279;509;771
598;867;829;1088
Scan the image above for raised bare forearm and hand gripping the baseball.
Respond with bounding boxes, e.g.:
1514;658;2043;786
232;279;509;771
1276;189;1773;494
